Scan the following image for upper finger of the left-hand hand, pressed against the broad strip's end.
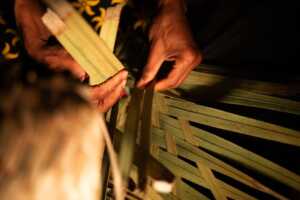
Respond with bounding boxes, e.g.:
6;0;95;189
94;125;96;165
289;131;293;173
91;70;128;99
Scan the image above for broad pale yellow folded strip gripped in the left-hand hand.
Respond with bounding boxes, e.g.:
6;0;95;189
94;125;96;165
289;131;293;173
43;0;123;85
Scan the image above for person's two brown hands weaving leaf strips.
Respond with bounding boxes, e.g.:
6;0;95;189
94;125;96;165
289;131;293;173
15;0;202;112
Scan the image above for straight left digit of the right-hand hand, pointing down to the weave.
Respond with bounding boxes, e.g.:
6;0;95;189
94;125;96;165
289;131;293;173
137;39;165;88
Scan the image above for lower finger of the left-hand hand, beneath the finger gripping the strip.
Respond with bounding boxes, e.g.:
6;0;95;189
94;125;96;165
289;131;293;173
98;80;126;112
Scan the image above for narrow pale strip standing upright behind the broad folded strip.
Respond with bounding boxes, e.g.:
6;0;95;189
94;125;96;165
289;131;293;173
100;3;126;51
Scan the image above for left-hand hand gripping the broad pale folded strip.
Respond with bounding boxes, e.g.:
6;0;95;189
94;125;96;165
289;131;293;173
15;0;127;112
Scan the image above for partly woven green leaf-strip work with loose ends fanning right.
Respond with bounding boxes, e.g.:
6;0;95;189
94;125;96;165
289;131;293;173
110;66;300;200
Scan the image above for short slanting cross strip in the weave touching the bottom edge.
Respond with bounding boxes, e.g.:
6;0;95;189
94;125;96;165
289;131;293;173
196;162;227;200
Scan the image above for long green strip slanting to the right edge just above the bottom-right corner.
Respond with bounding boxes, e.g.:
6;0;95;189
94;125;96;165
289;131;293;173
158;115;300;190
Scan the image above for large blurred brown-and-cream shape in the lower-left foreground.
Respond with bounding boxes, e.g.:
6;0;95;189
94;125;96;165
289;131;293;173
0;66;104;200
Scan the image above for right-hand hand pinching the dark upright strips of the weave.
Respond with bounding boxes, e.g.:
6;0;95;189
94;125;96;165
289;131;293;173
137;0;202;90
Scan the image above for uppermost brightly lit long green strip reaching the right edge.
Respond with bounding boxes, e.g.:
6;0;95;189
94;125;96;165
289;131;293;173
161;94;300;146
